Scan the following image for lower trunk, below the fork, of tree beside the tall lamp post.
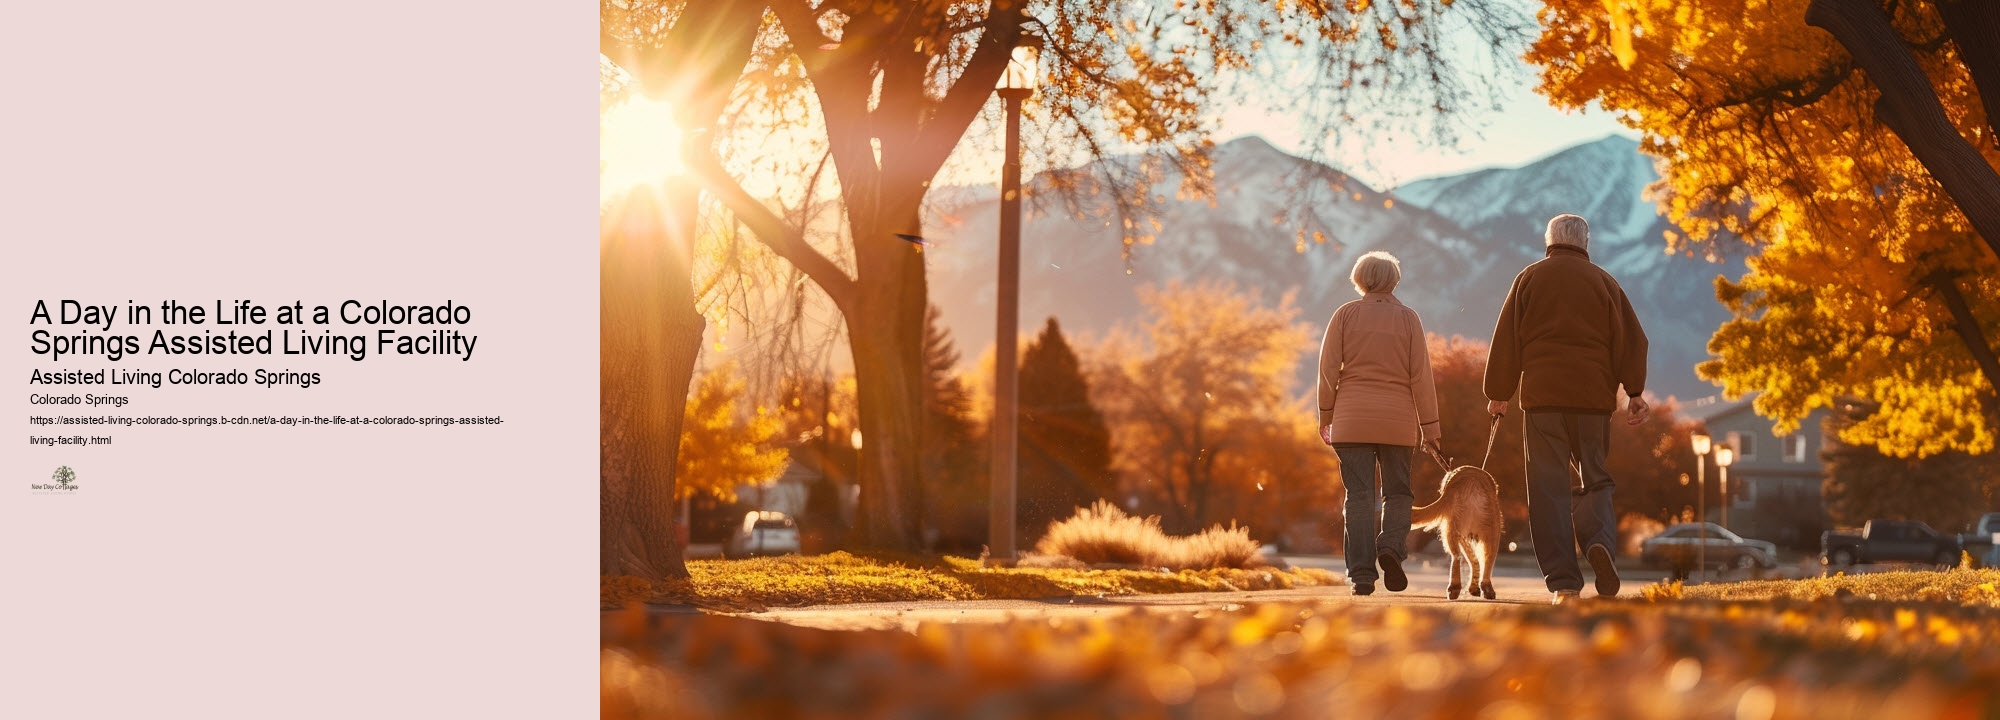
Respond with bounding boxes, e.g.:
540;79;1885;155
846;200;928;550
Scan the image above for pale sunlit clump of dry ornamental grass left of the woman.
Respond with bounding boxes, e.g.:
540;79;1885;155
1034;500;1266;570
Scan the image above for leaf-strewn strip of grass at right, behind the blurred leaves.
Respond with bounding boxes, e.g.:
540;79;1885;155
1644;568;2000;608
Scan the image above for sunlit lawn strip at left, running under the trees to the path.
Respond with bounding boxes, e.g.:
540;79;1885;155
600;552;1342;610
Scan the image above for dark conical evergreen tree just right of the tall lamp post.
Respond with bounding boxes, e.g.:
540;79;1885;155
922;306;988;552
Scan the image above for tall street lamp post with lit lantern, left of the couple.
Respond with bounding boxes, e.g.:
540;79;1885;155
986;36;1040;562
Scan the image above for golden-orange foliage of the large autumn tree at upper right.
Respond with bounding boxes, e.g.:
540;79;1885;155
1530;0;2000;456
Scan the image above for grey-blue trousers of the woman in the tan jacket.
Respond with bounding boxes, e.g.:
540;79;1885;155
1334;444;1416;584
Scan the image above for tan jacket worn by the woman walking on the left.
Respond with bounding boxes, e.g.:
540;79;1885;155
1320;292;1438;446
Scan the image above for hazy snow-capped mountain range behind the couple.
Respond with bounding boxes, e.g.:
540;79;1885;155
924;138;1726;398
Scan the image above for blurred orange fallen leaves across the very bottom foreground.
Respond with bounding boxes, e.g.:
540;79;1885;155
600;600;2000;720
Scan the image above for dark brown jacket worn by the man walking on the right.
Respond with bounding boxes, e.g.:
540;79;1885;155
1486;244;1646;414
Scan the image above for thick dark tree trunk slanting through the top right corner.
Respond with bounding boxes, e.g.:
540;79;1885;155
1806;0;2000;254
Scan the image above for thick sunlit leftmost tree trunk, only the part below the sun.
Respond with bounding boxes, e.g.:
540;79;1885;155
598;184;706;580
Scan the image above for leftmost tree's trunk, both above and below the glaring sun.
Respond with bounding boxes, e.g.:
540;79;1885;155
598;2;764;580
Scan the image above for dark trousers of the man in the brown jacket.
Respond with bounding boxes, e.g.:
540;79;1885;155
1522;412;1618;592
